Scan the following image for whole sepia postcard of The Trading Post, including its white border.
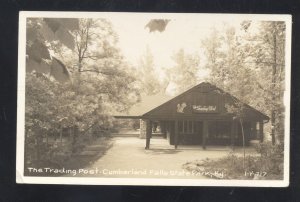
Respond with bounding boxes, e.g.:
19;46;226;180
16;11;291;187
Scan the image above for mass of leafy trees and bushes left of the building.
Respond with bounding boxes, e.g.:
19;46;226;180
25;19;139;170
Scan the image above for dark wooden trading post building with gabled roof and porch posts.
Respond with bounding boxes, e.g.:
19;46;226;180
115;82;269;149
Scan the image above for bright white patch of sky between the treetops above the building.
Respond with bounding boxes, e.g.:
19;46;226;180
110;16;241;71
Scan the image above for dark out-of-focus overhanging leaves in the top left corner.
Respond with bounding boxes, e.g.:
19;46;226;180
26;18;79;82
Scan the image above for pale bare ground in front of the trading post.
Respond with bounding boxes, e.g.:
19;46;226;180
64;137;254;178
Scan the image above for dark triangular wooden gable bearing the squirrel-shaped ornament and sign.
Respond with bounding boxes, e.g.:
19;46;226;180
143;82;269;120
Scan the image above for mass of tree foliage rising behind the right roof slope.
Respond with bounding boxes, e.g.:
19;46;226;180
202;21;285;144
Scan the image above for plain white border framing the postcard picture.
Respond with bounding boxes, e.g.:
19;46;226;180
16;11;292;187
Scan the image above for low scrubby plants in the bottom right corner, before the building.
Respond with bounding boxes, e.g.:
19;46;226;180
183;147;283;180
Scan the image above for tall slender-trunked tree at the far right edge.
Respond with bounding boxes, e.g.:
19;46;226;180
255;21;285;145
